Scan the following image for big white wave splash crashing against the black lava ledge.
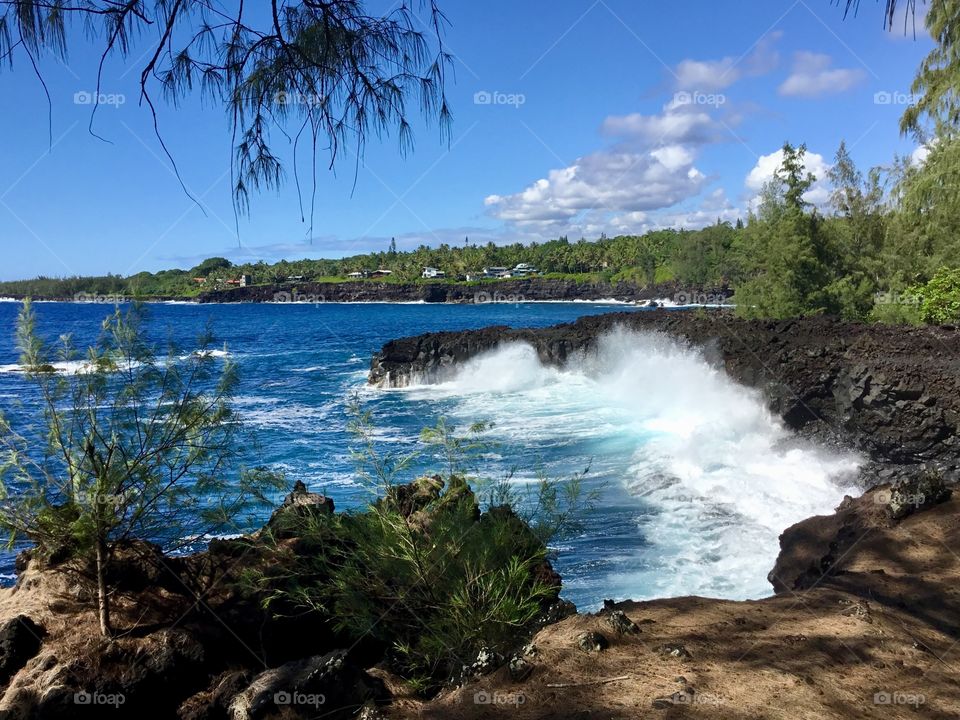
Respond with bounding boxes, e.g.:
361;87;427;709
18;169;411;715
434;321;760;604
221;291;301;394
402;331;860;598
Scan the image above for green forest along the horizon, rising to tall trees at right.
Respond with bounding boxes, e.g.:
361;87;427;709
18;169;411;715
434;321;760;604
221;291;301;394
0;2;960;323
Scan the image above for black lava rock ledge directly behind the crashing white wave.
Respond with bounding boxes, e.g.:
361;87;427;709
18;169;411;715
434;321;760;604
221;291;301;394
369;311;960;481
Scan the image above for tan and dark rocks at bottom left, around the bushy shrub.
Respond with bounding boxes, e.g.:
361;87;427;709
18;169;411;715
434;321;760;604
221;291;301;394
0;476;575;720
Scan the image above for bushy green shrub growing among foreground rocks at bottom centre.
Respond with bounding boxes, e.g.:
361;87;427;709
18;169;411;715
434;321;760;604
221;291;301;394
258;411;595;690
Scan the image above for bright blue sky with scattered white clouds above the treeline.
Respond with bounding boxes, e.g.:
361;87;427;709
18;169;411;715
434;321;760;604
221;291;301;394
0;0;931;279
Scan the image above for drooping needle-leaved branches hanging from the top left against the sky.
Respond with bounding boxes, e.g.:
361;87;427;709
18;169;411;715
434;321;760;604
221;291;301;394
0;0;451;225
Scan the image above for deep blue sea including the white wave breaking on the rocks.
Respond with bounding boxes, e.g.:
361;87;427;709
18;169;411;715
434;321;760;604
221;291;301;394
0;302;858;609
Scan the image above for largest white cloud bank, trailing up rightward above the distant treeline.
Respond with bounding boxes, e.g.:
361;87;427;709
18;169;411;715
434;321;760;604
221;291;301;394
484;33;780;235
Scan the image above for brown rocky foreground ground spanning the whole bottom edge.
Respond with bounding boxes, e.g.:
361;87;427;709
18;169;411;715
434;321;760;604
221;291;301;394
0;475;960;720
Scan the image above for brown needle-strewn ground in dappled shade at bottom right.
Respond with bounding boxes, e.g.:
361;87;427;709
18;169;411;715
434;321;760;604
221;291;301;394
387;495;960;720
